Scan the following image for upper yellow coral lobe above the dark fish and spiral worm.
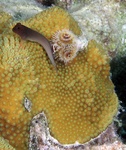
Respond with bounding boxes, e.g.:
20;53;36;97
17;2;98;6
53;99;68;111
24;7;81;39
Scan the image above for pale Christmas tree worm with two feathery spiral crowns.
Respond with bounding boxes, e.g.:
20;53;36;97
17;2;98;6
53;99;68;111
52;29;79;63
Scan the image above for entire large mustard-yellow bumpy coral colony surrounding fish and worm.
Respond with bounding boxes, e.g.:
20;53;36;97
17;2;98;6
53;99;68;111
0;7;118;150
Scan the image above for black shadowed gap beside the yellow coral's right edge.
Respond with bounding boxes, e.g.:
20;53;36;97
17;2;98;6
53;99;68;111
111;57;126;144
